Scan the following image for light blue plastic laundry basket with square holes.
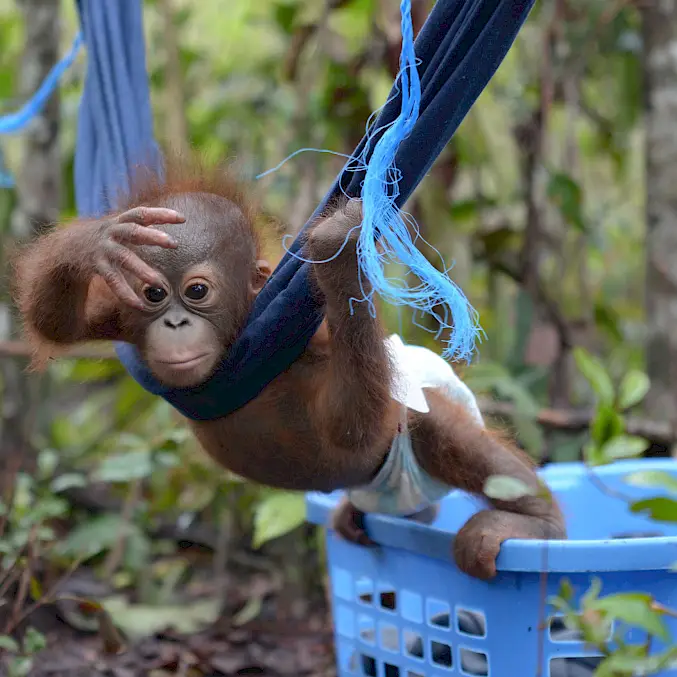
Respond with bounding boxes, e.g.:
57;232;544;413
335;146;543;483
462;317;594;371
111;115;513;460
307;460;677;677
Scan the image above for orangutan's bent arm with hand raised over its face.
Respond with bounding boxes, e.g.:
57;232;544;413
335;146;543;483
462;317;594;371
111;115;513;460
12;207;183;362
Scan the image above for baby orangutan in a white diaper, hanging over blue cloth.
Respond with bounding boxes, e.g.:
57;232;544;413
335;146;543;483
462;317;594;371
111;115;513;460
14;161;565;579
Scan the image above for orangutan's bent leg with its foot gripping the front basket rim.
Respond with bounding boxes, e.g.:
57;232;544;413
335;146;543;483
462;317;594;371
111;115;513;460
411;390;566;580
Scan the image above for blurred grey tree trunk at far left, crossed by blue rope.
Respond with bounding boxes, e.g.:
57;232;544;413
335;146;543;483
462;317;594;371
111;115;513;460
0;0;61;476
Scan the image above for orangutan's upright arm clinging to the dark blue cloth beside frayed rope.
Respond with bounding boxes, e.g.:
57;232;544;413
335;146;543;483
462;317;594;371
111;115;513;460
306;201;398;460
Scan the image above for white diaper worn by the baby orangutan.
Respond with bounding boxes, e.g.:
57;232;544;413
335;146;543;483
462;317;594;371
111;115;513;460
346;335;484;516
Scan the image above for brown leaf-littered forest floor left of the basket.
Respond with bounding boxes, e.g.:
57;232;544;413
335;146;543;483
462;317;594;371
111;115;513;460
0;556;336;677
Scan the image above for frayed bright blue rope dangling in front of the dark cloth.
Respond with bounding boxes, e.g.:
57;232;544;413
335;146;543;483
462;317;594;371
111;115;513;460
257;0;483;361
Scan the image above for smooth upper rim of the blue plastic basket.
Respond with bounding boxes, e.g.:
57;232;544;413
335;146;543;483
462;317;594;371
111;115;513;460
306;459;677;574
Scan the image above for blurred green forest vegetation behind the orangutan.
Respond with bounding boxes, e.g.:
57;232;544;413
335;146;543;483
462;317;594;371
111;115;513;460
0;0;677;672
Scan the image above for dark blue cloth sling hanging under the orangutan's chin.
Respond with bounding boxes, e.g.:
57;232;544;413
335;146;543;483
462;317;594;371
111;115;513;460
76;0;535;420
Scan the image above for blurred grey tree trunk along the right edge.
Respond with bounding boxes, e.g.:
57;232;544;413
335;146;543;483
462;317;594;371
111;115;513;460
643;0;677;430
